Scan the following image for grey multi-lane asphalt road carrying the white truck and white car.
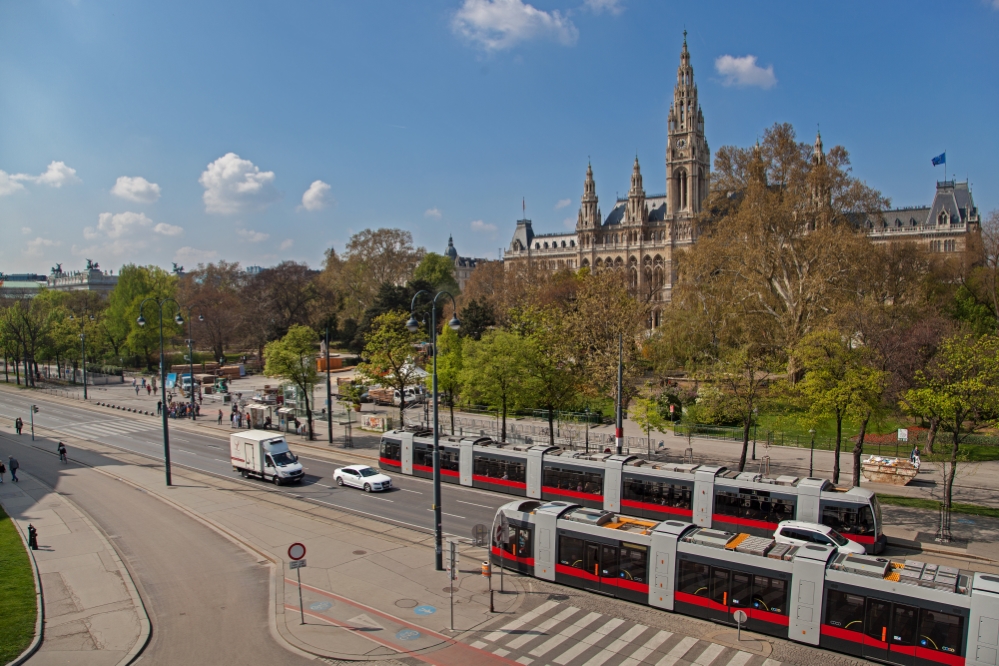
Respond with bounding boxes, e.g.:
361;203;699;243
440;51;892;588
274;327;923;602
0;392;514;538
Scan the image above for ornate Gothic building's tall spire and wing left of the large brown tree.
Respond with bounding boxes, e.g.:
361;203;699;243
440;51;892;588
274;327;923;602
503;33;711;327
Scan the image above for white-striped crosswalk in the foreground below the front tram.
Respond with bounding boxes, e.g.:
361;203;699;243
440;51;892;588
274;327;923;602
472;601;781;666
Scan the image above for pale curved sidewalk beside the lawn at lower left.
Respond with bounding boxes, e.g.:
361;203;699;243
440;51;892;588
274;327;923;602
0;472;149;666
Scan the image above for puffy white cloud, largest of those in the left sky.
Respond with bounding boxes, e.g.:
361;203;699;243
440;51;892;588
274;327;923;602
198;153;281;215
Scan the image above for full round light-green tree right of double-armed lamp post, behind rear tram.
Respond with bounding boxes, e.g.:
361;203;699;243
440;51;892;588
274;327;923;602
461;330;528;441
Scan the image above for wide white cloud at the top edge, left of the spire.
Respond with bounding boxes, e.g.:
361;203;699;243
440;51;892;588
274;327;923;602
451;0;579;51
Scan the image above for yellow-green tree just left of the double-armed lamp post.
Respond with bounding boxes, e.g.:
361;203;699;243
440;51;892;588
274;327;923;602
357;311;422;426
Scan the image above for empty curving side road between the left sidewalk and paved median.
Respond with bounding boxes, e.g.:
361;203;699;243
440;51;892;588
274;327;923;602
0;428;313;665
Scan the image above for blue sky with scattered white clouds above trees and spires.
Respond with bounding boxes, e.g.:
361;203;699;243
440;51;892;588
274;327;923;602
0;0;999;273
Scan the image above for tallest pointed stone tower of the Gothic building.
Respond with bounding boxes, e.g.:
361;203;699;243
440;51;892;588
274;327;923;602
666;30;711;226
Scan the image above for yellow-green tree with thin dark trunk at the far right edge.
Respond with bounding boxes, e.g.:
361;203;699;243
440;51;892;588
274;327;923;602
902;333;999;510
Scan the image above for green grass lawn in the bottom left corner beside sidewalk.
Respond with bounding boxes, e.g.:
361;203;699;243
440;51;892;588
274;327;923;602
0;509;38;664
